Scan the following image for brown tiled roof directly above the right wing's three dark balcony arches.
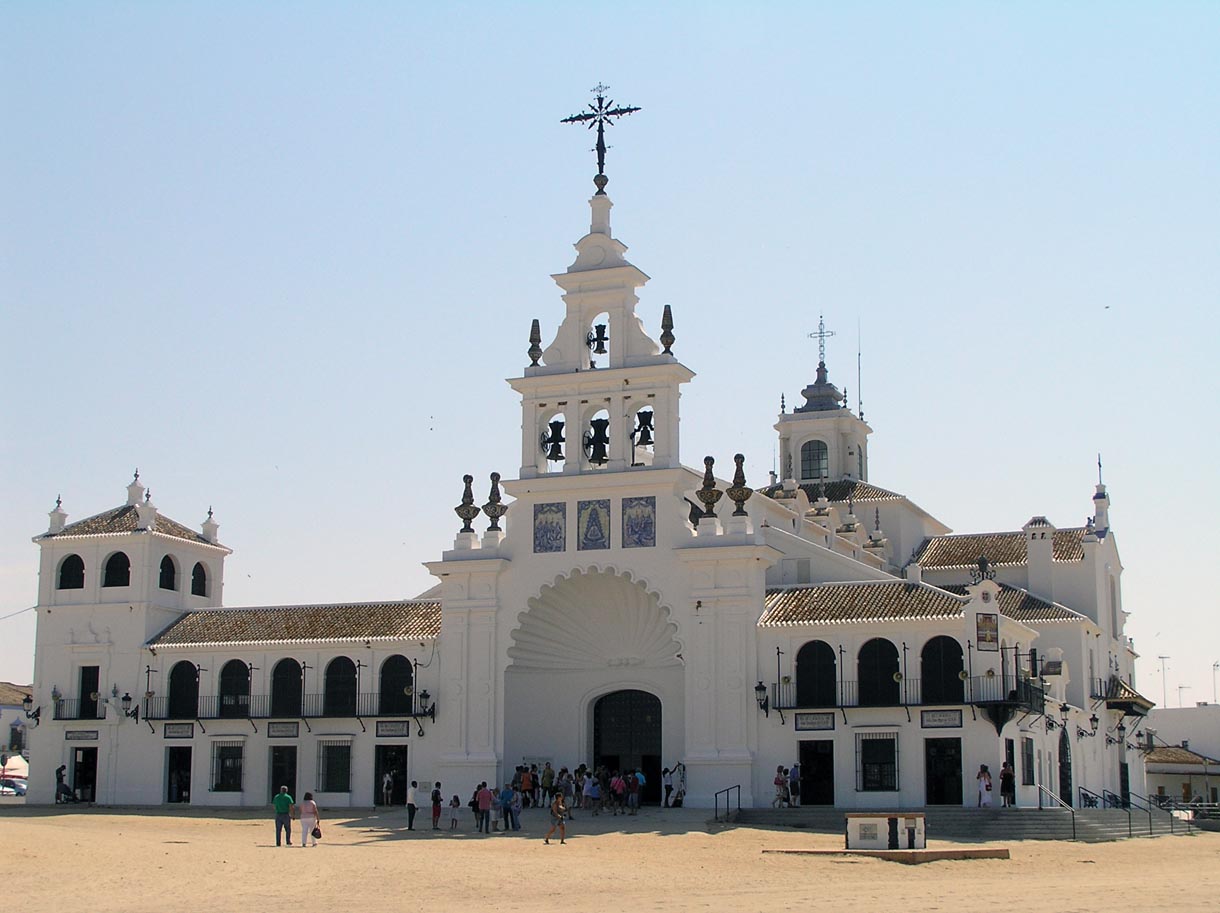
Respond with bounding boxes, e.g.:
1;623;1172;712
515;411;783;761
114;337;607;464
759;581;966;627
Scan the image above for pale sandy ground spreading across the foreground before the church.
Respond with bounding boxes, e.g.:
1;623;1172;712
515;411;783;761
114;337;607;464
0;803;1220;913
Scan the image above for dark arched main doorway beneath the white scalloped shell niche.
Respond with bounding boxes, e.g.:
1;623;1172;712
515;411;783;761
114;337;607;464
593;690;661;804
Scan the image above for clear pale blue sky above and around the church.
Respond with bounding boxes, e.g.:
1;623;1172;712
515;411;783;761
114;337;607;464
0;2;1220;706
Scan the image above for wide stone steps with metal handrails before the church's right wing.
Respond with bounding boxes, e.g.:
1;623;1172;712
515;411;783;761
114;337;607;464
736;806;1187;842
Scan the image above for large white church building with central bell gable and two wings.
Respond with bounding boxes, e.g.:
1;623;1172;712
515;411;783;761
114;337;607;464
27;166;1150;809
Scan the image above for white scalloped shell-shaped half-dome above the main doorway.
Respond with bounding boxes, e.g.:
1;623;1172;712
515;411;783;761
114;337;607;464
509;570;681;669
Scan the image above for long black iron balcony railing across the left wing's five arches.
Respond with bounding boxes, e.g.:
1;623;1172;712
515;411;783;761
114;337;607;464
144;692;412;720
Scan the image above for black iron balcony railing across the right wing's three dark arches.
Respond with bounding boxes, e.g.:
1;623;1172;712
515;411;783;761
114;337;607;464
771;675;1046;713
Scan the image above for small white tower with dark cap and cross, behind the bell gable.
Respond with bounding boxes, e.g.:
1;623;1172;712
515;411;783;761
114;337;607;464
775;317;872;493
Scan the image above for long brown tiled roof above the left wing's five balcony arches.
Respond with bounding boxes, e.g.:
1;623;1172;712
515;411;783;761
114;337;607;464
149;599;440;647
